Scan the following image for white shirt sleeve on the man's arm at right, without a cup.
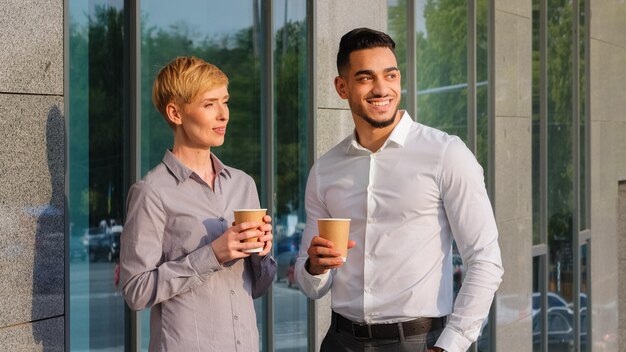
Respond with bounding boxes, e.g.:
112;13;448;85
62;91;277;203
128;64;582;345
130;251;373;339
436;138;504;352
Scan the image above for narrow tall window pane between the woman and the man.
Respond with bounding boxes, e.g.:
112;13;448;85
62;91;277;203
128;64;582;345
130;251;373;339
272;0;309;352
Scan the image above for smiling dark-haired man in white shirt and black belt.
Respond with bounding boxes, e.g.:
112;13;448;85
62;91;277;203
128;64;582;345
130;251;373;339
295;28;503;352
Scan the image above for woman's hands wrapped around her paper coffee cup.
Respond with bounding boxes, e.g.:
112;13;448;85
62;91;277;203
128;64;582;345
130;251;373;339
211;222;264;264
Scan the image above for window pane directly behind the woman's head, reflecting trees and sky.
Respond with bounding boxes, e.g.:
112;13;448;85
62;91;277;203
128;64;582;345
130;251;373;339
141;0;264;349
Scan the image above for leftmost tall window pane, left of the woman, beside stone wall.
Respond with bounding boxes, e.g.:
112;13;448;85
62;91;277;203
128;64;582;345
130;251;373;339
66;1;128;351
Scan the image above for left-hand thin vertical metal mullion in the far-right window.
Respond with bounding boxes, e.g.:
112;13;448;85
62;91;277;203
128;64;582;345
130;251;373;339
539;0;550;351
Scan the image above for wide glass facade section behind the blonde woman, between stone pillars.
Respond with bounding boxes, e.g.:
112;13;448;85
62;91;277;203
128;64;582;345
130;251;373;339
68;0;310;351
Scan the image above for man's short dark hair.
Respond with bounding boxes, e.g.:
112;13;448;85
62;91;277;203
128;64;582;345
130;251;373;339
337;28;396;75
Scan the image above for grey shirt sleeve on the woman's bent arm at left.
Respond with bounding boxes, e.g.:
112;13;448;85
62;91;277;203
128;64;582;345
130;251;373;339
120;181;222;310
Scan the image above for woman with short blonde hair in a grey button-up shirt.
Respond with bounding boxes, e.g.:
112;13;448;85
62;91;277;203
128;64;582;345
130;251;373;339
120;57;276;352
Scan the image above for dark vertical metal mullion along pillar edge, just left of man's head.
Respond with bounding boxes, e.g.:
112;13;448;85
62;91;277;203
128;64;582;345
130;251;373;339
306;0;321;352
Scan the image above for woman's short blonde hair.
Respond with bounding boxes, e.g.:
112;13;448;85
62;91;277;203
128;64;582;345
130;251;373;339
152;56;228;128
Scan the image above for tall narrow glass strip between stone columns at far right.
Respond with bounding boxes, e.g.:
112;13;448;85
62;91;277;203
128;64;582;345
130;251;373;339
533;0;590;351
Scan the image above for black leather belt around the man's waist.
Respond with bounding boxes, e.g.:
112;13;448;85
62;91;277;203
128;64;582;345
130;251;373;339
333;312;446;339
